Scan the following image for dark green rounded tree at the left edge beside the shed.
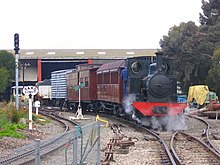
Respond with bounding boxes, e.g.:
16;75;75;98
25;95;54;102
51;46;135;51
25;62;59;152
0;50;15;93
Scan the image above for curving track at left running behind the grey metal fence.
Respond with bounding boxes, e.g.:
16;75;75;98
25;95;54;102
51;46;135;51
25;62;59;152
0;111;78;165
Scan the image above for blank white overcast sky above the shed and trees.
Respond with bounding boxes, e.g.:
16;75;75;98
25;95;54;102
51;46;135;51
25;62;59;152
0;0;202;49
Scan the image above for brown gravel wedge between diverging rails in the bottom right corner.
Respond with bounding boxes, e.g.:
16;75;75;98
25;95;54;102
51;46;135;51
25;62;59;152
171;131;220;165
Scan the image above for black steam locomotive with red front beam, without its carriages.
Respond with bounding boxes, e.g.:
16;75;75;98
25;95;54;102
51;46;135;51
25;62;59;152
127;52;187;116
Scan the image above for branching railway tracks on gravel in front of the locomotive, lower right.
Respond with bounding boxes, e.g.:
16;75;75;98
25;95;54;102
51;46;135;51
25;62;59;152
100;113;220;164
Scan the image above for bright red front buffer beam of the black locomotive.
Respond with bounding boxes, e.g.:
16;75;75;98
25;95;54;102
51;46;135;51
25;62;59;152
133;102;187;116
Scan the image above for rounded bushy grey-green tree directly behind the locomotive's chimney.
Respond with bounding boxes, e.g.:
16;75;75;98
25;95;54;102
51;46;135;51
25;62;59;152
160;21;211;93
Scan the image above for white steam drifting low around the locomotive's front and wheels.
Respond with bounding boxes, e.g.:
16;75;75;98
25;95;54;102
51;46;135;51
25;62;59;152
123;94;187;131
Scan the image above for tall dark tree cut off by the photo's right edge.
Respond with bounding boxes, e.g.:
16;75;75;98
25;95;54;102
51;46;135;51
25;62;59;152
200;0;220;95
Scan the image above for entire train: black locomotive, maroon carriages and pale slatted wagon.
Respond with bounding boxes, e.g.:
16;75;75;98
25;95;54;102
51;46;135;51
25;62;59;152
37;52;186;128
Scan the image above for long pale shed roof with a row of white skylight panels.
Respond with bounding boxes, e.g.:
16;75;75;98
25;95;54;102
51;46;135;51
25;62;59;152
4;49;157;59
